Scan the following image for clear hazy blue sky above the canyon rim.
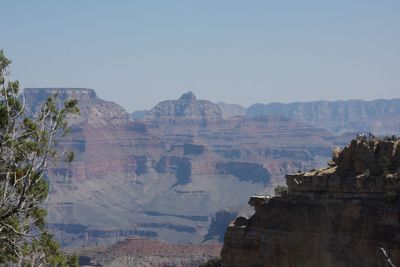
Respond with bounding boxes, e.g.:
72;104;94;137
0;0;400;111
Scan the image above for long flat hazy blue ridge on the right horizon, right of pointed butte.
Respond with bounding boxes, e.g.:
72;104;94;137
246;98;400;134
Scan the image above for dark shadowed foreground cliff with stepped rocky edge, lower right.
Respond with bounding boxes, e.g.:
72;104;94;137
221;138;400;267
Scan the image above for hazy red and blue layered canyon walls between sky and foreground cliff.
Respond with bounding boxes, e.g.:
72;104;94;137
24;88;400;247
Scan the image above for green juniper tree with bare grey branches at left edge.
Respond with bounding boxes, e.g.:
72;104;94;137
0;50;78;266
